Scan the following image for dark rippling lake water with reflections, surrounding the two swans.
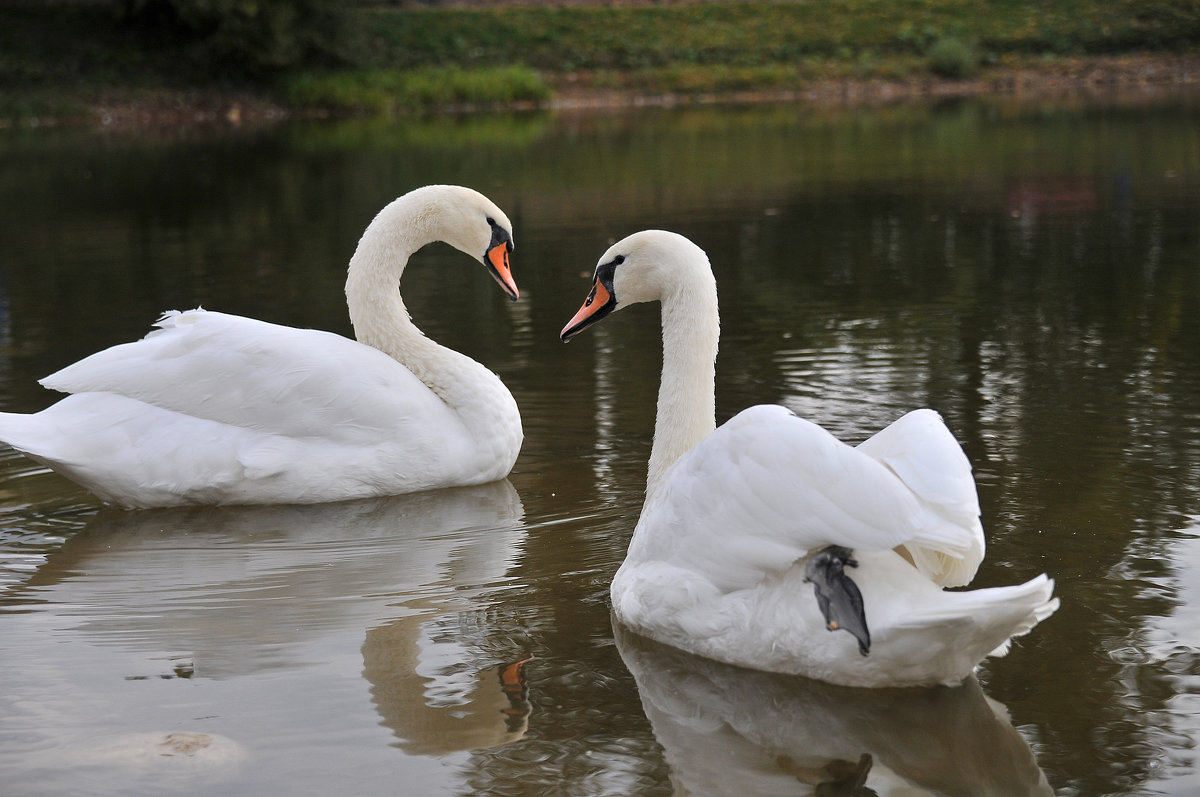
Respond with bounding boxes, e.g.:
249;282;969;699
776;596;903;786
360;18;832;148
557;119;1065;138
0;97;1200;797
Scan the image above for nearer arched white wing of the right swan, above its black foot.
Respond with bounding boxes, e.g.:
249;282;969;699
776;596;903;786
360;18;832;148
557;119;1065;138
629;406;974;591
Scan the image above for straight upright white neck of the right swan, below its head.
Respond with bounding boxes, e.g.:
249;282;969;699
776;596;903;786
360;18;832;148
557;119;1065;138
646;277;721;497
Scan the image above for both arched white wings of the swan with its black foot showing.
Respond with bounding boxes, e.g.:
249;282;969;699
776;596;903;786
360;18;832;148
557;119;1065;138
630;405;983;591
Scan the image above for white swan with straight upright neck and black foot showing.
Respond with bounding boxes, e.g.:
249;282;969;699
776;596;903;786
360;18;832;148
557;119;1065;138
562;230;1058;687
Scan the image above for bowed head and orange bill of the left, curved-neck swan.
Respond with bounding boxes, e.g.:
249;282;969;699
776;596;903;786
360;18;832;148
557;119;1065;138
406;185;521;301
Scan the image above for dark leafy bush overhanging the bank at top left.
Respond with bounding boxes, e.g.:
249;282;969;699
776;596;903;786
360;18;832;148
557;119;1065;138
116;0;346;74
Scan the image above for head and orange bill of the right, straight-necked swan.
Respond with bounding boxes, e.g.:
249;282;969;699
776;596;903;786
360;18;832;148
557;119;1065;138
559;229;715;343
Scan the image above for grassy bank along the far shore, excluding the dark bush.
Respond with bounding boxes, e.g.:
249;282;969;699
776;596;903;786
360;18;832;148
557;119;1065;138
0;0;1200;124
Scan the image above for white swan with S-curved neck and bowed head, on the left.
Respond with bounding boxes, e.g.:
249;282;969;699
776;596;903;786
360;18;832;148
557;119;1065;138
0;185;522;508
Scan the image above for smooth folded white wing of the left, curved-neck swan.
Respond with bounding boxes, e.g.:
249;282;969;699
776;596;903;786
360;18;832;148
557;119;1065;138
42;310;458;444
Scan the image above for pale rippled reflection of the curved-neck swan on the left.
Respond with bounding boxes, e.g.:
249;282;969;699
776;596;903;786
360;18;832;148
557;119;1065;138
9;481;529;760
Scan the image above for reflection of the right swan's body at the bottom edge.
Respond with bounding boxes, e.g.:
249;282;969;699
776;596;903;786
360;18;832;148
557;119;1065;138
613;619;1054;797
